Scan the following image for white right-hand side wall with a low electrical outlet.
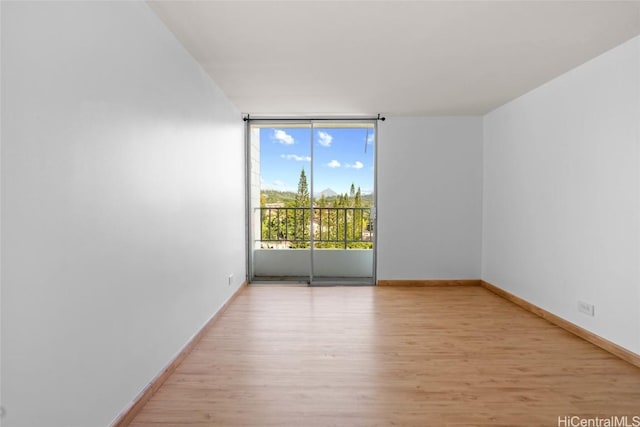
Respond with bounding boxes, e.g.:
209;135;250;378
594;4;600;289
482;38;640;353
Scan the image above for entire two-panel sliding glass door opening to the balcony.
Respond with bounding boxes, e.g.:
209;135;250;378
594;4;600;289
247;121;376;285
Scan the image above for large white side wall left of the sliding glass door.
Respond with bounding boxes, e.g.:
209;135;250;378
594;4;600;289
1;2;245;427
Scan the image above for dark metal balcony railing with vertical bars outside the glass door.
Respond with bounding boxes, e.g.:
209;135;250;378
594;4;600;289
256;207;373;249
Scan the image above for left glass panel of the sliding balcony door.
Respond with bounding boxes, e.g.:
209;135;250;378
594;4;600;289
250;123;311;283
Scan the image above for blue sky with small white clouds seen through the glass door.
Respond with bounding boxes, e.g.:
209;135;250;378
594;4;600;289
260;126;374;194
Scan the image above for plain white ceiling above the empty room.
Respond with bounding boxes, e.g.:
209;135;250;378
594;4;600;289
149;0;640;115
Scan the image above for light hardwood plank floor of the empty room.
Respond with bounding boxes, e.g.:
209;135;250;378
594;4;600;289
131;286;640;427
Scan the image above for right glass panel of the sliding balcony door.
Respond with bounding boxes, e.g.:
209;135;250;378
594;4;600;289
311;122;375;285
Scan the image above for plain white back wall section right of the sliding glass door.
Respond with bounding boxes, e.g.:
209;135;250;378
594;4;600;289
378;117;482;280
